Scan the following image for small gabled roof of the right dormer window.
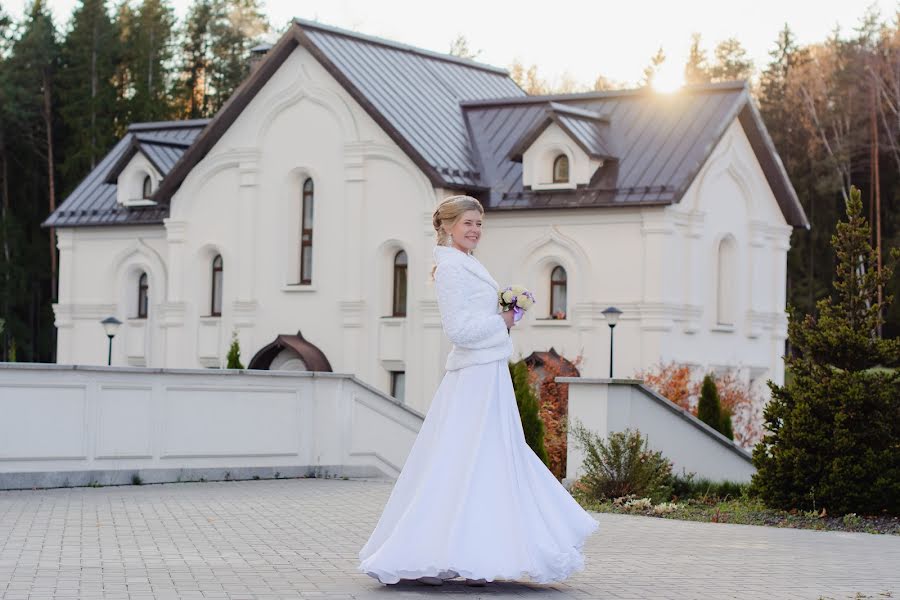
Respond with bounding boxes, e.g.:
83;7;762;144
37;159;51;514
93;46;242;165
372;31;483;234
507;101;615;162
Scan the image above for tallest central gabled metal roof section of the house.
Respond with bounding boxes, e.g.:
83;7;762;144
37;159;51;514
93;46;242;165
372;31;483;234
153;19;525;202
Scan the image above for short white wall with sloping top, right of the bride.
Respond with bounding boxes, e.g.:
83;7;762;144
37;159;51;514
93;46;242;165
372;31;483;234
556;377;756;487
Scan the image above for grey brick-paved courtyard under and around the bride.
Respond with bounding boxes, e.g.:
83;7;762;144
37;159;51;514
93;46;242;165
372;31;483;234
0;479;900;600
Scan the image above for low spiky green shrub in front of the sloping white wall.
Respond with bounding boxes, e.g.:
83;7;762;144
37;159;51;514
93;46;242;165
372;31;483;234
569;419;673;502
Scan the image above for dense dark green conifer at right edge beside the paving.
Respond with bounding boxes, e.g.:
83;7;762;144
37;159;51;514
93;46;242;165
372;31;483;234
751;186;900;514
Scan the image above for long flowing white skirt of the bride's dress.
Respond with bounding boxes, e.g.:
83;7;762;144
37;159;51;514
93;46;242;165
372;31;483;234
358;359;599;583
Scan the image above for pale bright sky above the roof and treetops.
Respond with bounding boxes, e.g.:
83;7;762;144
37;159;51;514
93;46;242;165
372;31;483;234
7;0;900;87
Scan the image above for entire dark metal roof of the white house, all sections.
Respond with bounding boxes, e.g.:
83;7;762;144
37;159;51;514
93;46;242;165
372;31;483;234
44;20;809;227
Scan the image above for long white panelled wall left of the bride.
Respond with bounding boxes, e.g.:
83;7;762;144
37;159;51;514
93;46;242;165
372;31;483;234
0;363;424;489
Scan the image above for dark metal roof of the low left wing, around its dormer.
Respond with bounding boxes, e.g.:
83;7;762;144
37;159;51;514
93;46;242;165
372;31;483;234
41;119;209;227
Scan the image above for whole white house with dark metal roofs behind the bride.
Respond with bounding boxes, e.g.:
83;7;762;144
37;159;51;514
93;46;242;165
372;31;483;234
44;20;808;412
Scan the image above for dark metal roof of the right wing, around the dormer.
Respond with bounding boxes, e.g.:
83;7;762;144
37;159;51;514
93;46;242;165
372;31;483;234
462;81;809;228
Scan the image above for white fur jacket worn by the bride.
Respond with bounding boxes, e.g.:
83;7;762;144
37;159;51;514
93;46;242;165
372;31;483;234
432;246;513;371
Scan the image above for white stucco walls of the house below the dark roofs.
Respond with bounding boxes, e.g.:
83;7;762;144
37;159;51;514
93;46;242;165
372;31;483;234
55;43;790;412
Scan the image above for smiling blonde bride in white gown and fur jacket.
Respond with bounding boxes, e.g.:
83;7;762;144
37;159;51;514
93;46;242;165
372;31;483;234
358;196;599;585
